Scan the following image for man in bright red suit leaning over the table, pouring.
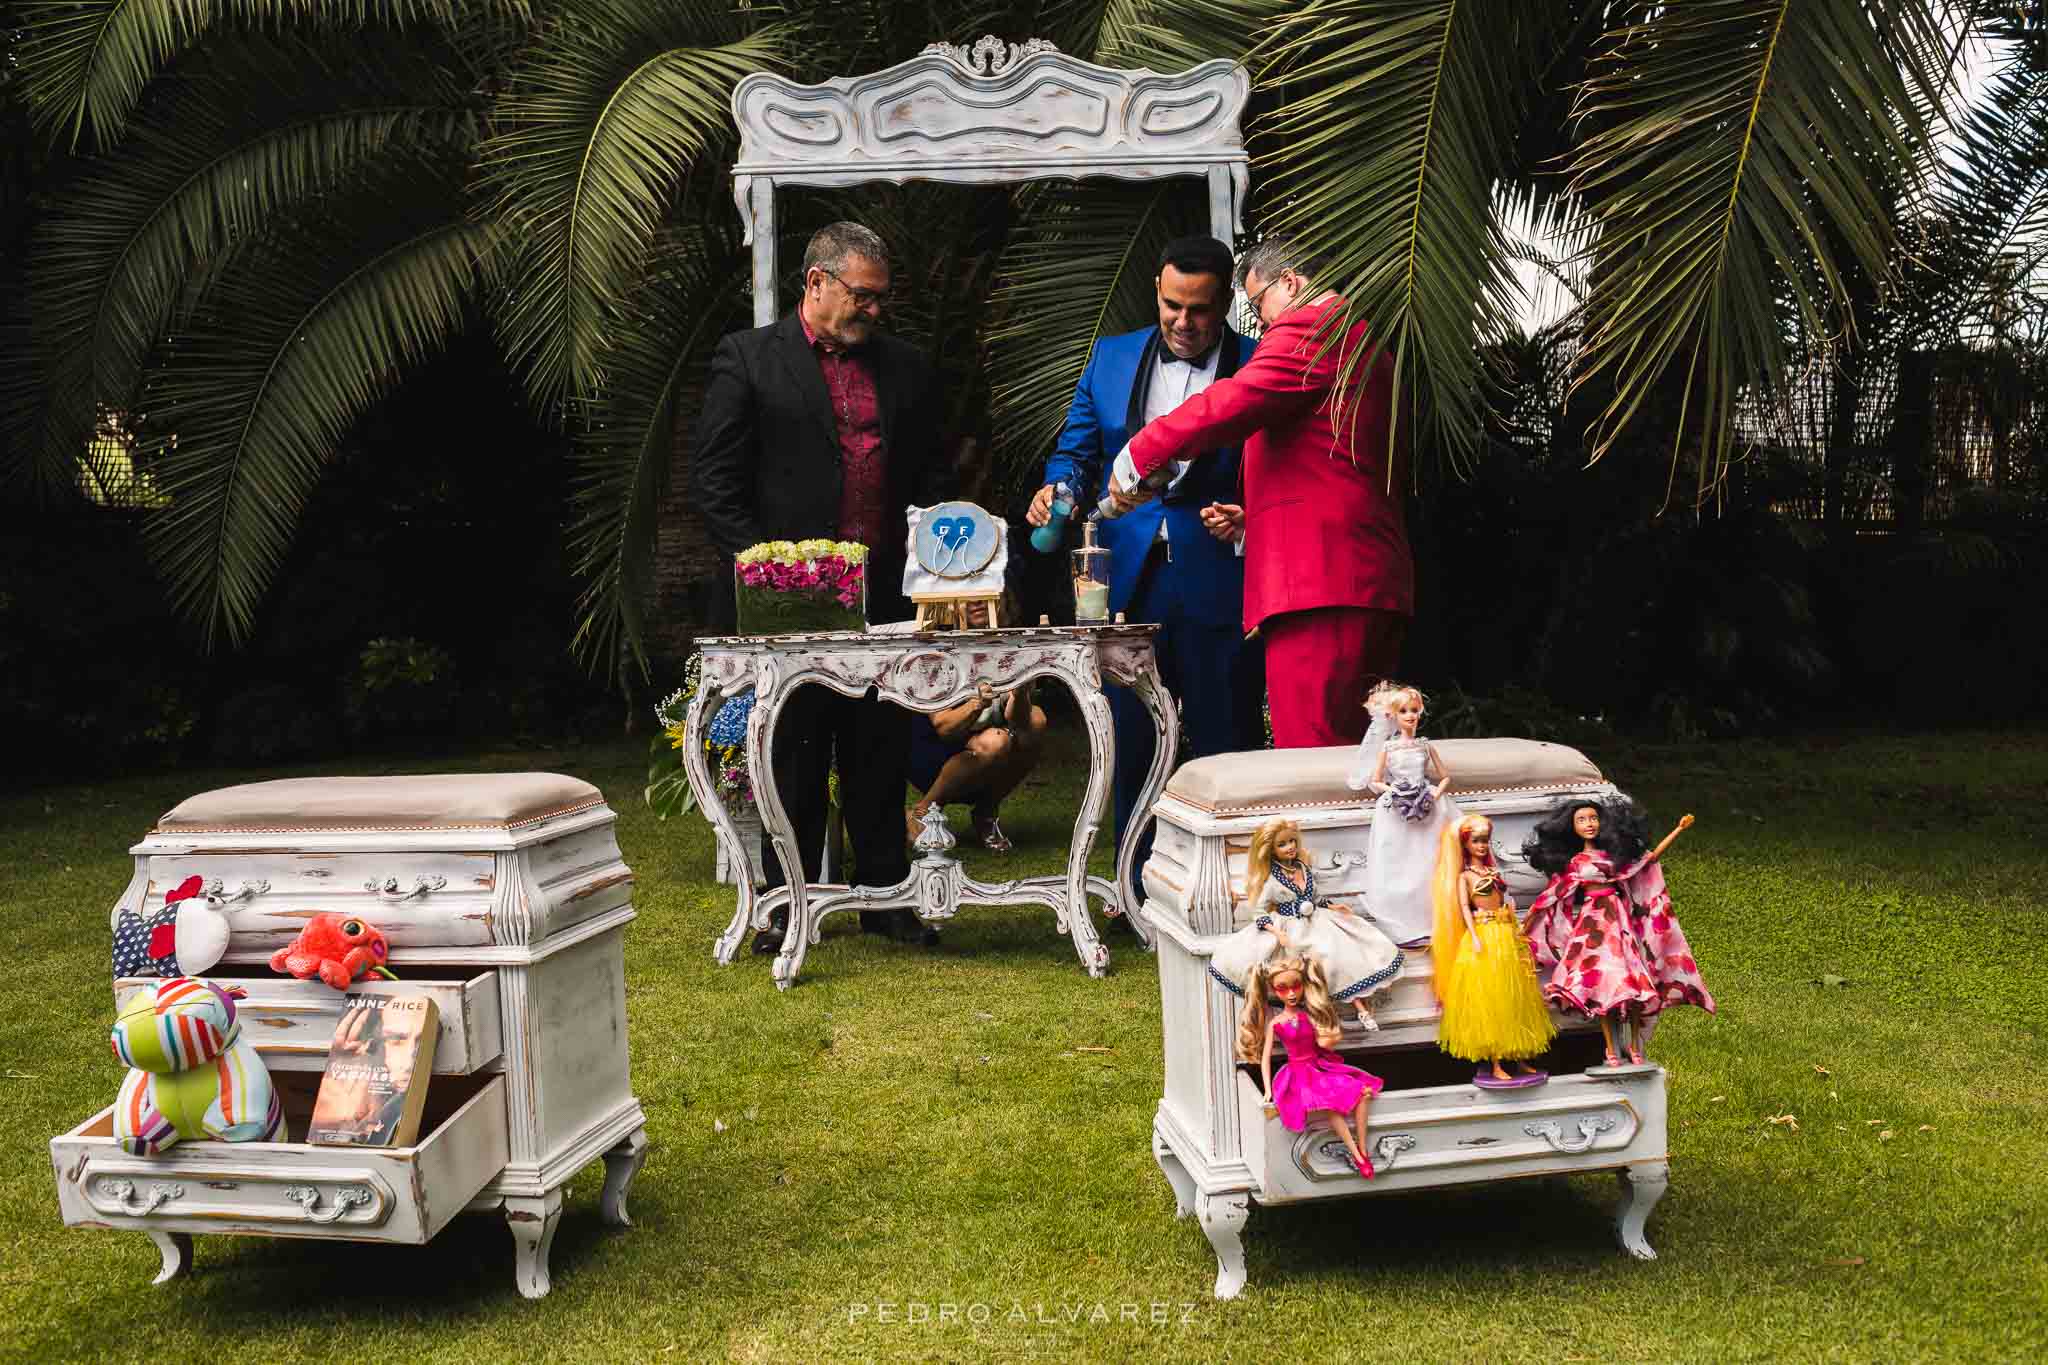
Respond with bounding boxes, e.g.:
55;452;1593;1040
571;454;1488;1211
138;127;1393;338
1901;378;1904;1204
1110;237;1415;749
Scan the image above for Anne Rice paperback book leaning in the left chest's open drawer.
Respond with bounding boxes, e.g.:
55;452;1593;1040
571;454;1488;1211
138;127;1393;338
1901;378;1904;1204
305;993;440;1146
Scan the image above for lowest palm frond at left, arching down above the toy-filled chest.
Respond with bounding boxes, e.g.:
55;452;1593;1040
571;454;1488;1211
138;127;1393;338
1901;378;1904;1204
145;176;492;643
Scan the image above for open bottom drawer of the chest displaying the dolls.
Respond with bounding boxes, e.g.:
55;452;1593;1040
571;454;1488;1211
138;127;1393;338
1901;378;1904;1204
1237;1056;1665;1203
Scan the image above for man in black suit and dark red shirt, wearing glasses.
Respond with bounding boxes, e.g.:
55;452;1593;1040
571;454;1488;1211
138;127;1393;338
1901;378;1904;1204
690;223;942;952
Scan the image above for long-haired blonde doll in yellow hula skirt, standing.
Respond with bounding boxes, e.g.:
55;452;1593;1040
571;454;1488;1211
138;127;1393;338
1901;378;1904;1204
1430;814;1556;1089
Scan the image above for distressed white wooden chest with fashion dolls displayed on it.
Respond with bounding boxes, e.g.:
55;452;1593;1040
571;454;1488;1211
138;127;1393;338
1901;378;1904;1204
1143;739;1667;1300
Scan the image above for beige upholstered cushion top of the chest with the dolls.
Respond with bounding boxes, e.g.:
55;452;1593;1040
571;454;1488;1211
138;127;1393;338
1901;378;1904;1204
1165;739;1604;814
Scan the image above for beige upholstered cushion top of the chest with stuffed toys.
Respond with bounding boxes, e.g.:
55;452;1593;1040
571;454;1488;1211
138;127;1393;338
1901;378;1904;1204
156;774;604;833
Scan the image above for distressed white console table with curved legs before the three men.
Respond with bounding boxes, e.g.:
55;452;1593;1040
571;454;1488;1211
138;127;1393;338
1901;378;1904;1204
682;626;1180;990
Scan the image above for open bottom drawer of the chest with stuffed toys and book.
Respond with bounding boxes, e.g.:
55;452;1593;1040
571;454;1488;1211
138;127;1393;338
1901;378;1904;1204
49;1072;510;1242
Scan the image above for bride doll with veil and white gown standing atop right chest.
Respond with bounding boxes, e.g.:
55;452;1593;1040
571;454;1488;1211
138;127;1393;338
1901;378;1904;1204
1346;681;1464;945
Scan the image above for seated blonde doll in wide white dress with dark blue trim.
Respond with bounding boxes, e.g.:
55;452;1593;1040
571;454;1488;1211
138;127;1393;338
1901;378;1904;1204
1208;819;1401;1031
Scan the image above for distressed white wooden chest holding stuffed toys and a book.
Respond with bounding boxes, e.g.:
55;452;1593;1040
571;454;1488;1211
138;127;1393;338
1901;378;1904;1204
49;774;647;1297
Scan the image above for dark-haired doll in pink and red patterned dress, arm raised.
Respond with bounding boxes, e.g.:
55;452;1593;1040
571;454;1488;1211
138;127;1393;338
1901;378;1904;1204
1522;796;1714;1066
